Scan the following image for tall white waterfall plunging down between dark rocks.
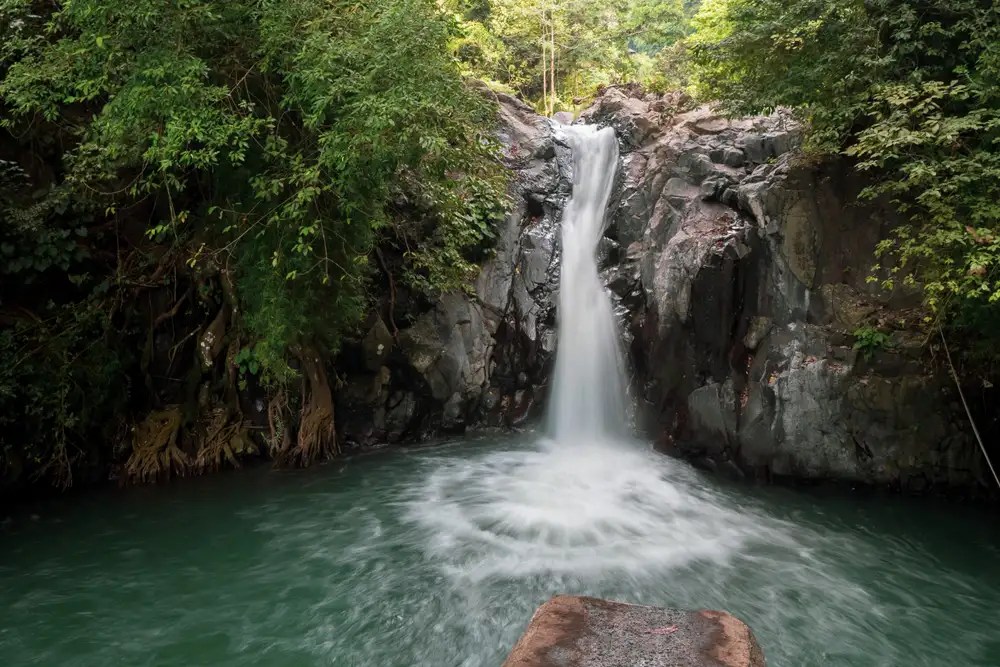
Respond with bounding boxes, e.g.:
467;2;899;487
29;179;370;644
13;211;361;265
549;125;625;442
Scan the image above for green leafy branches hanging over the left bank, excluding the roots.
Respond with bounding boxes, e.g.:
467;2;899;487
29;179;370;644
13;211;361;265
0;0;506;490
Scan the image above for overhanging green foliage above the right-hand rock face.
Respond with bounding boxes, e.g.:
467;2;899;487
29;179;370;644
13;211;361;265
688;0;1000;362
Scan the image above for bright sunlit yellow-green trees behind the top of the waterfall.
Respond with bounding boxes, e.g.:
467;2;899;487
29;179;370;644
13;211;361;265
444;0;698;112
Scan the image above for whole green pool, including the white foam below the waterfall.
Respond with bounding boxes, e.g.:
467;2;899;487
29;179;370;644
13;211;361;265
0;436;1000;667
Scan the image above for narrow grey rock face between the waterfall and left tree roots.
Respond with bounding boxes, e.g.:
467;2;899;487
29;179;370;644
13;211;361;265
337;94;568;447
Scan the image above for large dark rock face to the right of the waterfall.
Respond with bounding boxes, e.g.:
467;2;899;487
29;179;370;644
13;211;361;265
586;89;983;490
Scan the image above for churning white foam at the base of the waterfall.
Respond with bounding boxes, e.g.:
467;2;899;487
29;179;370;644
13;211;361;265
408;441;789;582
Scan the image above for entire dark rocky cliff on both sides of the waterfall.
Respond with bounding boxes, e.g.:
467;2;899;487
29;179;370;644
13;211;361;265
337;89;985;491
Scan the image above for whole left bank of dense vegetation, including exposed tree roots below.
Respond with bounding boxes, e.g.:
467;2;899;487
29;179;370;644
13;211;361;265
0;0;505;485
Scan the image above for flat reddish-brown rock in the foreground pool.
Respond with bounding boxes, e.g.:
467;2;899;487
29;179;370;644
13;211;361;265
503;596;765;667
